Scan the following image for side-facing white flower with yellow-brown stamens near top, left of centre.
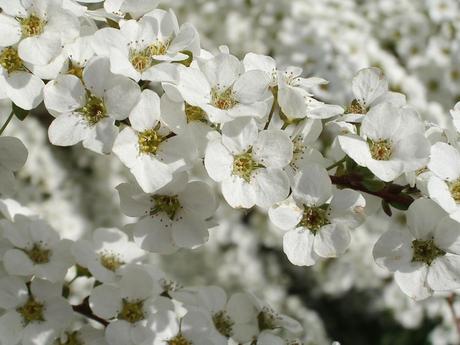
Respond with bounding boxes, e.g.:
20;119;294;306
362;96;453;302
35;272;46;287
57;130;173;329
94;10;199;81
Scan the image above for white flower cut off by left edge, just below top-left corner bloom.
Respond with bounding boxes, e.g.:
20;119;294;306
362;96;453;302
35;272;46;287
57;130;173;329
0;45;45;110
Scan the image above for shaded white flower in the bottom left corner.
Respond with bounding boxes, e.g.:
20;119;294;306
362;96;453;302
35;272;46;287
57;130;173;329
0;276;73;345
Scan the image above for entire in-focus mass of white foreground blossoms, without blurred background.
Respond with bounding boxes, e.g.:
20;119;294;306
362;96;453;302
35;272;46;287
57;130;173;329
0;0;460;345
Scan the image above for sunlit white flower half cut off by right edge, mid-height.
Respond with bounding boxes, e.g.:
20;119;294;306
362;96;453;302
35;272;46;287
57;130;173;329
427;142;460;221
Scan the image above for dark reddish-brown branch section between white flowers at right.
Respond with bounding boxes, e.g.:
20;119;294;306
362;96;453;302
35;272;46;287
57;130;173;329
330;175;414;207
